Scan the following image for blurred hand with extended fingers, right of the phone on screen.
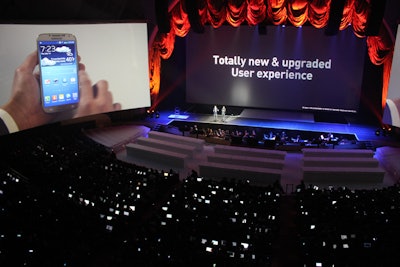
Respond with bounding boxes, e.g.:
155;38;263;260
74;68;121;118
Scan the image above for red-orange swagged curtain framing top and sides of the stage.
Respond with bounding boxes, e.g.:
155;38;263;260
149;0;394;114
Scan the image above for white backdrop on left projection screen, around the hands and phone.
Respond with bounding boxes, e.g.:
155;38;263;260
0;22;151;132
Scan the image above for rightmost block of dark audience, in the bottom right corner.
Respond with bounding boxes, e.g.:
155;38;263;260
296;185;400;267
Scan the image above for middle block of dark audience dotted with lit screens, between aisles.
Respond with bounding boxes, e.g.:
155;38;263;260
134;175;280;266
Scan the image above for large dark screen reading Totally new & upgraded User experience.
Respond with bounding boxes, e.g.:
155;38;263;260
186;26;366;113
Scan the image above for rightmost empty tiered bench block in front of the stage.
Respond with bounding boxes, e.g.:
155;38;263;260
302;148;385;184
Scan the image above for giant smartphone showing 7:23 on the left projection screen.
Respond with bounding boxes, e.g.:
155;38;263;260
37;33;79;113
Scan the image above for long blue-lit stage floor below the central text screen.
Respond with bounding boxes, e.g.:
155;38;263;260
147;107;393;146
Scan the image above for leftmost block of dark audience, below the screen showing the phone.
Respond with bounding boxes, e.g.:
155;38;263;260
0;131;179;266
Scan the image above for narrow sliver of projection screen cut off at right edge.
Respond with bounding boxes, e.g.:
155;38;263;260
383;25;400;127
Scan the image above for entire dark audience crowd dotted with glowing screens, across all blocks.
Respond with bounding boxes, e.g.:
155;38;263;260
0;124;400;267
